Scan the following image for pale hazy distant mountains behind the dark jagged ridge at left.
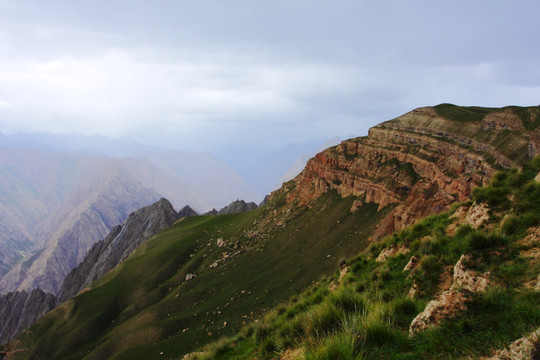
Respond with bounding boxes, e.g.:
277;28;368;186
0;147;257;295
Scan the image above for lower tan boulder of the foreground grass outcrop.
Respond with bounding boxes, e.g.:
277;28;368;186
409;290;472;336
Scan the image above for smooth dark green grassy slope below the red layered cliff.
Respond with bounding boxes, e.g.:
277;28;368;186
13;192;392;359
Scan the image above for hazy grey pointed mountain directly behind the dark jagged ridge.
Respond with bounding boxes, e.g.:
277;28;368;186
0;160;159;294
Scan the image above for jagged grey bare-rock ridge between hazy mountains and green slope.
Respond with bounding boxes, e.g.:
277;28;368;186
57;198;179;303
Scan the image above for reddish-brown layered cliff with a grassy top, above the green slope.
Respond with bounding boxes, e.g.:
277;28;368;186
272;104;539;237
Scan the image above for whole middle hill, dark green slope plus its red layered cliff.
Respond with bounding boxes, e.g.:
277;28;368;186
6;105;539;359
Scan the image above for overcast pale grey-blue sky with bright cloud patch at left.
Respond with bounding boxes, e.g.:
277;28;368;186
0;0;540;150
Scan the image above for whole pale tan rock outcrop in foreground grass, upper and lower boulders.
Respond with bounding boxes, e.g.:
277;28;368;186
409;255;489;336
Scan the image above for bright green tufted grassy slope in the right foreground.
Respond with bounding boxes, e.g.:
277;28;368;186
192;157;540;359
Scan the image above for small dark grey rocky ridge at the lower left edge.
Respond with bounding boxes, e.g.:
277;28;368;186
0;289;55;344
